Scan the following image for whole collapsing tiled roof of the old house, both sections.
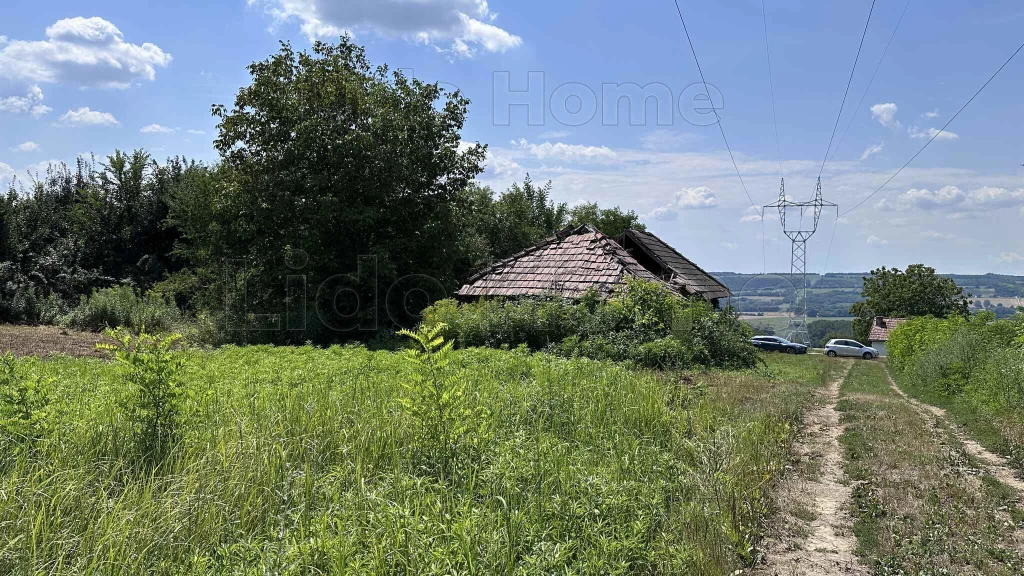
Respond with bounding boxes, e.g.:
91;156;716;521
458;224;730;303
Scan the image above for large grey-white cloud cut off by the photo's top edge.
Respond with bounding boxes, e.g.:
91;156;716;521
248;0;522;57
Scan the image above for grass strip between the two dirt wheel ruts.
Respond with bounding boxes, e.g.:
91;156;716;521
838;363;1024;575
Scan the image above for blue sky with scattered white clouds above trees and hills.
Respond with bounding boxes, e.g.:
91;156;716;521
0;0;1024;274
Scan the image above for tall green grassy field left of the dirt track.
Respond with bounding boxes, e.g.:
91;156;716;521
0;338;834;575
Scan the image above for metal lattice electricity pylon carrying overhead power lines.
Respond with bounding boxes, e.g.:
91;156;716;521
762;177;839;342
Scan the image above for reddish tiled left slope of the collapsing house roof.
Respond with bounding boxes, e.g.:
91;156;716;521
459;224;662;298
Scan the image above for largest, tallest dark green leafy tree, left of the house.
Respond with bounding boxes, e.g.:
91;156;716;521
171;37;485;339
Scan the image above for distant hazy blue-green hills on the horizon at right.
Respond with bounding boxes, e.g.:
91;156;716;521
712;272;1024;318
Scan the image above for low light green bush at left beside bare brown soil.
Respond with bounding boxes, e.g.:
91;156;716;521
63;286;181;333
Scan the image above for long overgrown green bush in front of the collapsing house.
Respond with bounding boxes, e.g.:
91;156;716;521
424;280;758;369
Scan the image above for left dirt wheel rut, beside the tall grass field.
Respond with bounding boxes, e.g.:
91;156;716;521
758;364;869;576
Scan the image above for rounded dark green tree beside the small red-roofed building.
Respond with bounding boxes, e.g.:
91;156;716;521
850;264;971;340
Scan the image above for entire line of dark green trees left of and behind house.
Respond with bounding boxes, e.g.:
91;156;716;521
0;38;643;342
